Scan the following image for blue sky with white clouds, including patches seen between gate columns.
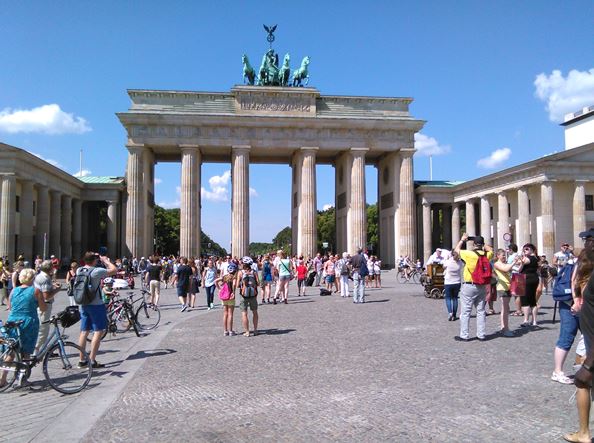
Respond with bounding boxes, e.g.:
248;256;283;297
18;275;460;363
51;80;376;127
0;0;594;247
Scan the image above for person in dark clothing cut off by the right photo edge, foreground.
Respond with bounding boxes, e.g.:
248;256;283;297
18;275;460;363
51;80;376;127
563;228;594;442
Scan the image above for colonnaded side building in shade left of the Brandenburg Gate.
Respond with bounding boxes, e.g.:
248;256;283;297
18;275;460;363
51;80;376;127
0;143;125;262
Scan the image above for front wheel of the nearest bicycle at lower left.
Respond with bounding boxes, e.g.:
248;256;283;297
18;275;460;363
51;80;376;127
43;341;93;394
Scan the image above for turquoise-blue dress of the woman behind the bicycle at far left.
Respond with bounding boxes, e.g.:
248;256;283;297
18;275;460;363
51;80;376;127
8;286;39;354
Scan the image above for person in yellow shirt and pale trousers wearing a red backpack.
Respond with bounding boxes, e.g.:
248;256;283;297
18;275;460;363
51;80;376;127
454;233;493;341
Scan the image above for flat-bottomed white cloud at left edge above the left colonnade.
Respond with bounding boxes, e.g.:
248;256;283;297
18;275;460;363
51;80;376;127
0;103;91;134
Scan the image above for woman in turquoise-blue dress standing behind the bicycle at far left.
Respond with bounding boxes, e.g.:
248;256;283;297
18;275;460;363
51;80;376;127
7;269;47;358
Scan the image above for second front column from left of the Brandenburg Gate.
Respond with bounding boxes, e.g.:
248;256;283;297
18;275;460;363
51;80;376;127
180;145;201;257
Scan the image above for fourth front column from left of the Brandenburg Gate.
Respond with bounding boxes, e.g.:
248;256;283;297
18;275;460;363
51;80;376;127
291;147;316;257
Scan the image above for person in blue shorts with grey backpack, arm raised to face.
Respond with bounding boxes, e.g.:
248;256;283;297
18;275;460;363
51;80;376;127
74;252;118;368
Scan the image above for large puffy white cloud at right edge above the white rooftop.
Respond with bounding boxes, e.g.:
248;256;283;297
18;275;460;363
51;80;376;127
534;68;594;123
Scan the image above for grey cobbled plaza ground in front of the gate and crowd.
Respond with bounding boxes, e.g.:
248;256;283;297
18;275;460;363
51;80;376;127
0;271;577;442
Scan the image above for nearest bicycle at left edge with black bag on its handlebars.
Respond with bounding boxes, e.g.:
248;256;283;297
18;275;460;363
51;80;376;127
0;306;93;394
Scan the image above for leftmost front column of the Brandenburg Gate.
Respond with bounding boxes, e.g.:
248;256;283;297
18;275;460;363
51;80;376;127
126;146;146;257
